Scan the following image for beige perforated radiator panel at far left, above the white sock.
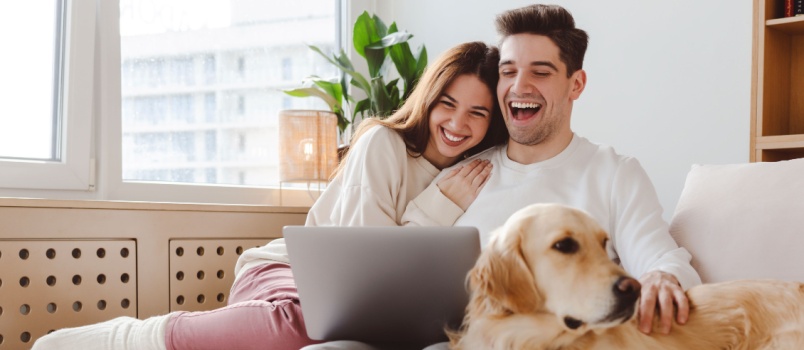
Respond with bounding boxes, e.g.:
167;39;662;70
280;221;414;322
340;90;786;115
0;240;137;349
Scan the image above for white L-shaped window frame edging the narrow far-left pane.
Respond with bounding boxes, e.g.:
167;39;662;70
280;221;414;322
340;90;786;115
0;0;96;191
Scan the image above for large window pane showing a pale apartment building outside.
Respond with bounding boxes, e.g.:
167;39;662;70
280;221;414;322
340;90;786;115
120;0;338;186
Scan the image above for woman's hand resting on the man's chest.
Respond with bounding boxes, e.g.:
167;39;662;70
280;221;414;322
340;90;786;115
436;159;492;211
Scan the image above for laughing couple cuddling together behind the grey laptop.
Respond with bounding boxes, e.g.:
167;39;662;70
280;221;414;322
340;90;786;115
34;5;700;350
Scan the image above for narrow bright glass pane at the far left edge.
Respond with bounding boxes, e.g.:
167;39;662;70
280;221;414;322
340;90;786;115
0;1;62;160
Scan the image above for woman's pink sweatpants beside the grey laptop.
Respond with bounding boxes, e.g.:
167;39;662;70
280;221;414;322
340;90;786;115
165;263;317;350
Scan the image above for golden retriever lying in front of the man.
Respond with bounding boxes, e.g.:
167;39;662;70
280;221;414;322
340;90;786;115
449;204;804;350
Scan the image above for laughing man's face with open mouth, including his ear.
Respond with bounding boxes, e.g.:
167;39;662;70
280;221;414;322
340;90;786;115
497;34;585;145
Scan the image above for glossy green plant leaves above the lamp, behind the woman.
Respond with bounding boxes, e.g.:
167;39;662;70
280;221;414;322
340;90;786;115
284;11;427;137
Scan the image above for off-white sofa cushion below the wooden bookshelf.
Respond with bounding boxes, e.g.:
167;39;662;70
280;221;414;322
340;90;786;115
670;159;804;283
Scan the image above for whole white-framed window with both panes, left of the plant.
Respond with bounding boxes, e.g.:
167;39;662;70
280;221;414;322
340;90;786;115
0;0;343;205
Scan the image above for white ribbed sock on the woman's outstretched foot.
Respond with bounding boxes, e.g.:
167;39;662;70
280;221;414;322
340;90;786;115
31;314;172;350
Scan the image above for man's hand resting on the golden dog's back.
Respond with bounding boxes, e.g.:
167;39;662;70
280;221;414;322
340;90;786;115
639;270;690;334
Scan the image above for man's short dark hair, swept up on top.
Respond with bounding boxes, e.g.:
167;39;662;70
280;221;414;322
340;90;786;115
496;4;589;77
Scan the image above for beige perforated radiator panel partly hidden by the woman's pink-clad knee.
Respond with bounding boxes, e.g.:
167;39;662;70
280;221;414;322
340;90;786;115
170;239;270;311
